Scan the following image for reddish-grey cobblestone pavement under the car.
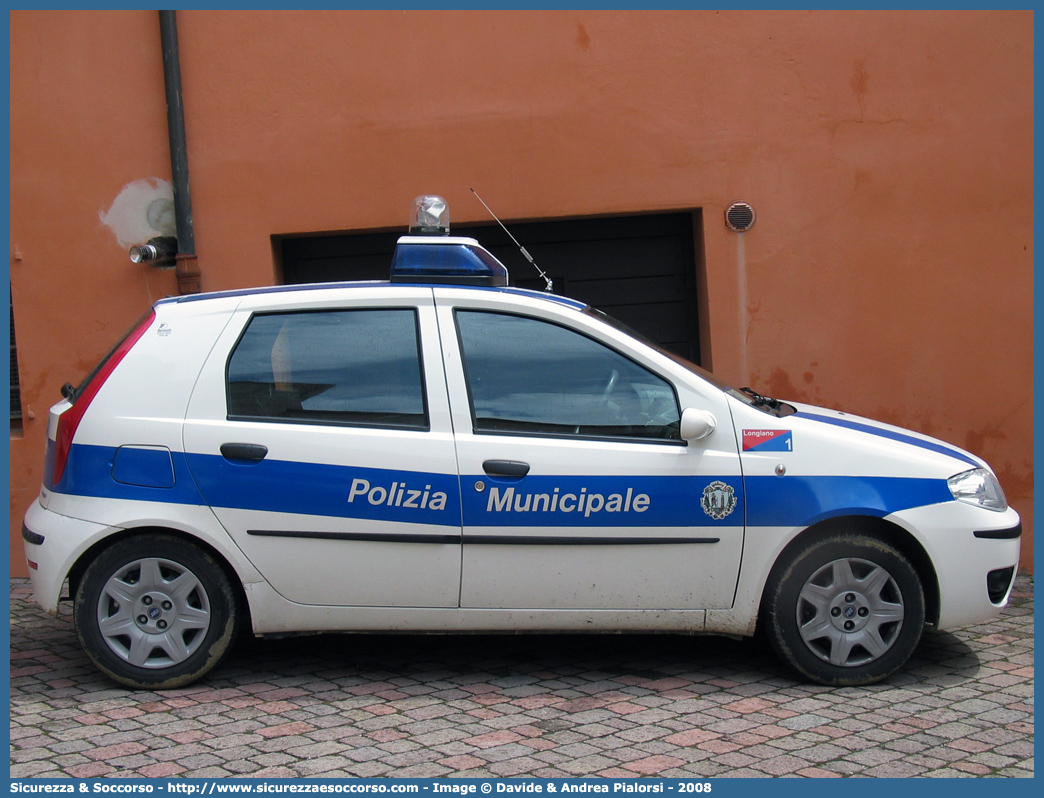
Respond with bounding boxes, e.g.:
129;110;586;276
10;578;1034;778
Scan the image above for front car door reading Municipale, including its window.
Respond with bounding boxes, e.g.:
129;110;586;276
435;288;743;610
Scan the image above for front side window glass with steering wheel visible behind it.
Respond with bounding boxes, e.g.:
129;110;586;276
456;310;680;441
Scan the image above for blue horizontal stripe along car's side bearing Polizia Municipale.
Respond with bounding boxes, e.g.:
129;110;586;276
54;444;953;527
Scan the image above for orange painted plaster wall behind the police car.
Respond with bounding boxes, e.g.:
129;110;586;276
10;10;1034;573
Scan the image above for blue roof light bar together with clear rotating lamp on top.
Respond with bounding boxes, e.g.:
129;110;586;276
392;194;507;286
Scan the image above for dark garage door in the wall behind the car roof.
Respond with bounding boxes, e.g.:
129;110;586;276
281;213;702;363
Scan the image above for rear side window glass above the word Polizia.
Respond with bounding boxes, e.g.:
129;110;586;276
228;308;428;429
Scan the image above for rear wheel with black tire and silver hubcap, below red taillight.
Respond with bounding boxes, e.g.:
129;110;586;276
73;534;239;689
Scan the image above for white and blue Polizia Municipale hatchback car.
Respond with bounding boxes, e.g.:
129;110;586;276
23;196;1021;688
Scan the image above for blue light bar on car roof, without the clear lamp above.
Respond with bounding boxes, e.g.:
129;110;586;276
392;236;507;286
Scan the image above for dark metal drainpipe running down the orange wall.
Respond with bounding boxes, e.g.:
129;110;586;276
160;11;200;295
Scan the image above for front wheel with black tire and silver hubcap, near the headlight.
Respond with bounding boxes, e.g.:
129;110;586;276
763;534;925;686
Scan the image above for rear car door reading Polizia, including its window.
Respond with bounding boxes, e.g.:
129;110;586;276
185;285;460;607
